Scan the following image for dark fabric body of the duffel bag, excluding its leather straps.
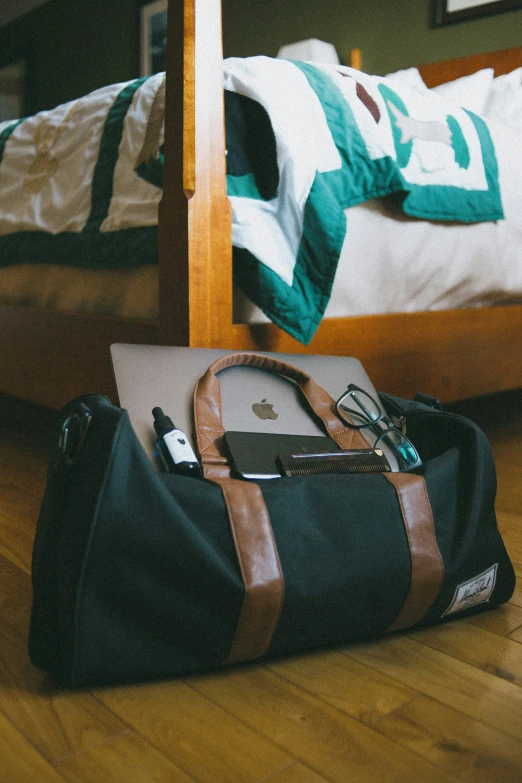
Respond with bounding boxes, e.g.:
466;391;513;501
30;397;514;686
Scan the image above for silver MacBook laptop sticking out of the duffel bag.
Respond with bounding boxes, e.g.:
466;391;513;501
111;343;395;469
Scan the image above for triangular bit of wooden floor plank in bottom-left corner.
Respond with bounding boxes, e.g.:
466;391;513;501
0;712;64;783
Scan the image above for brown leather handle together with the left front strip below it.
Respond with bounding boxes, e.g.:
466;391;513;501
194;353;367;663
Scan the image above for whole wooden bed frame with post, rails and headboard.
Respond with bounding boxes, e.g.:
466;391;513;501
0;0;522;408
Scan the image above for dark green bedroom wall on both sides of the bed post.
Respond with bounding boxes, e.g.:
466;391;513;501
0;0;522;112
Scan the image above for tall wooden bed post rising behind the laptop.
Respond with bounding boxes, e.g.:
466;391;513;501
158;0;232;347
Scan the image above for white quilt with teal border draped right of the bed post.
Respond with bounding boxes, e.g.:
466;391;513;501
225;57;503;343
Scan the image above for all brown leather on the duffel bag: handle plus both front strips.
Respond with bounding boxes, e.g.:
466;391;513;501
194;353;438;663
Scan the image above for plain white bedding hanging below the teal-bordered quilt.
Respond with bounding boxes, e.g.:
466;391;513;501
236;116;522;323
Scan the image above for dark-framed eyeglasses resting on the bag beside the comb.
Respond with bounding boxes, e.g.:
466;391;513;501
335;383;422;470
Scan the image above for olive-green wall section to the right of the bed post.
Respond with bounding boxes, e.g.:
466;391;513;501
223;0;522;74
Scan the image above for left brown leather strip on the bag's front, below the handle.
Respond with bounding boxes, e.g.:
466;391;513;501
215;479;284;663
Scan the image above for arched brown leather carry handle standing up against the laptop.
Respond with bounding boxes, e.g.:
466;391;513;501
194;353;368;479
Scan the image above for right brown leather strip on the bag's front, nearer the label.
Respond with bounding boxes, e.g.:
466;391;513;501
383;473;444;631
